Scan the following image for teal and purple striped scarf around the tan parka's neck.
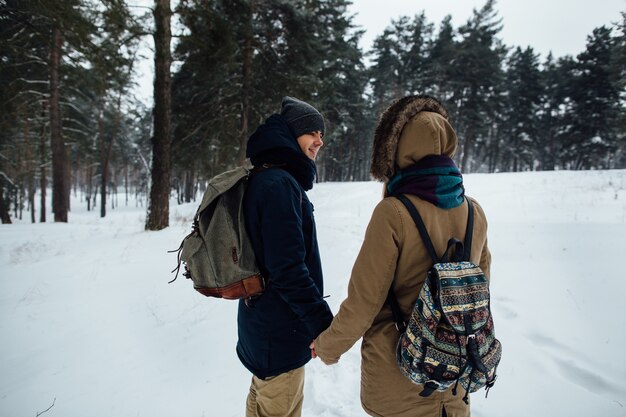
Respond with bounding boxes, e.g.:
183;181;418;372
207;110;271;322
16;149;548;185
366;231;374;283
387;155;465;209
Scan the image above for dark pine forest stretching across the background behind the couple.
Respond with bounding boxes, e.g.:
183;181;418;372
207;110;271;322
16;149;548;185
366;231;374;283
0;0;626;230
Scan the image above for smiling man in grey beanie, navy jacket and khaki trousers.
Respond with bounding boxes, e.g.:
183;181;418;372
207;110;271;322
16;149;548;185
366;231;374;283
237;97;333;417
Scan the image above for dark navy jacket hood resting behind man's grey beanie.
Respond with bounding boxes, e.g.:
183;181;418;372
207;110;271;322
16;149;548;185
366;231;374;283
246;114;302;158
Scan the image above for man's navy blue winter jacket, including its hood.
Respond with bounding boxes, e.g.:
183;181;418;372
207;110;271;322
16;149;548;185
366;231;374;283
237;115;332;378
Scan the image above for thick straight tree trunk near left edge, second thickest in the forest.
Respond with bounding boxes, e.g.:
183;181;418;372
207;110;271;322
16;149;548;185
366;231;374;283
49;27;69;223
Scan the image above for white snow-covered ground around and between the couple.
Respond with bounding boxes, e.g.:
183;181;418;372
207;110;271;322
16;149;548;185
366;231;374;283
0;171;626;417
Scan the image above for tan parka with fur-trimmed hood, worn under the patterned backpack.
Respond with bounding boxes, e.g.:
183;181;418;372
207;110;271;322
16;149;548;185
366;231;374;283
315;96;491;417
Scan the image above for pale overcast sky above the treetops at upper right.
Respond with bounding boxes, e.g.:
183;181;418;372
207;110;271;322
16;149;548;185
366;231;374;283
349;0;626;57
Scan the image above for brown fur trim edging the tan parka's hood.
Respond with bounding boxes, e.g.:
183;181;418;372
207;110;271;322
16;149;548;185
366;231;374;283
371;95;448;181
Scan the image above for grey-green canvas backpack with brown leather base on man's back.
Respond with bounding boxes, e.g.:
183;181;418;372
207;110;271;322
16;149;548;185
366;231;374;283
170;165;265;300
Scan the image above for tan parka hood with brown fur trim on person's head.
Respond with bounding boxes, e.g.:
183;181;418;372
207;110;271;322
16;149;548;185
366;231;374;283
371;95;458;182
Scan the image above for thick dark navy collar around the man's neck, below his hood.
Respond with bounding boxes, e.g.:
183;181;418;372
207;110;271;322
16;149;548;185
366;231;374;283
250;148;317;191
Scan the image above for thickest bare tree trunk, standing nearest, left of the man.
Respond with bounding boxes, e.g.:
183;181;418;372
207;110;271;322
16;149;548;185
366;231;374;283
146;0;172;230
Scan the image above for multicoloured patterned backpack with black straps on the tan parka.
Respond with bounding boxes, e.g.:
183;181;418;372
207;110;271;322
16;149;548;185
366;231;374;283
388;195;502;403
